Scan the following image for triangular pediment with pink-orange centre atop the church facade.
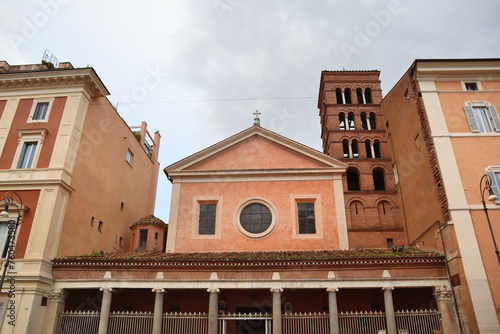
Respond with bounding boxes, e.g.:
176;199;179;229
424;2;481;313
164;126;347;175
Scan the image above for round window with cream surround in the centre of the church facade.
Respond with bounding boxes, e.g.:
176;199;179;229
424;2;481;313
235;198;277;239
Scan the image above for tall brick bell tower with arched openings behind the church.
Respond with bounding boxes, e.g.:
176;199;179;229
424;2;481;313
318;70;406;248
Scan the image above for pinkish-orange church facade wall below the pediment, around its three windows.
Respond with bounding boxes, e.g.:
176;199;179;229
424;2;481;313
175;180;339;252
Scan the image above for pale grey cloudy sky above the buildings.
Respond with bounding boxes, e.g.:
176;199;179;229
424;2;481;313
0;0;500;221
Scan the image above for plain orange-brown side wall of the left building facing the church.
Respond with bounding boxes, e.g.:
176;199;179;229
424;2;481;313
58;98;159;256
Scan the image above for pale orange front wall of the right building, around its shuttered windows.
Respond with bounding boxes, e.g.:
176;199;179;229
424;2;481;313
436;81;500;326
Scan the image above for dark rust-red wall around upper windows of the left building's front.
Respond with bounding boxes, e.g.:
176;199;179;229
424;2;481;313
0;97;66;169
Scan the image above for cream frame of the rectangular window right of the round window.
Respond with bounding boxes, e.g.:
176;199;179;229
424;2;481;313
290;194;323;239
